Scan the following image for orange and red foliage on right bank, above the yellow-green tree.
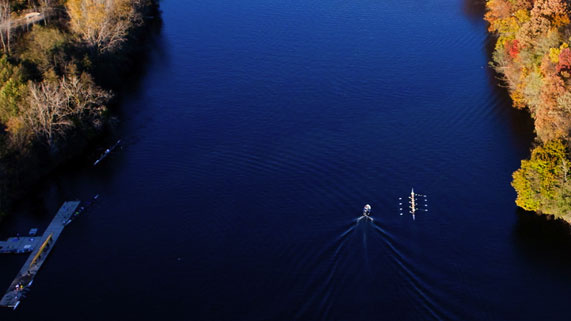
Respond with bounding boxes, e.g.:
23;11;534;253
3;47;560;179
485;0;571;140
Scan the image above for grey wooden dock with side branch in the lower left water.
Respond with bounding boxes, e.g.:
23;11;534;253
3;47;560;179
0;201;80;309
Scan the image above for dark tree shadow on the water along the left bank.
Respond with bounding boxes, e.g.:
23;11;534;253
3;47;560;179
0;15;165;242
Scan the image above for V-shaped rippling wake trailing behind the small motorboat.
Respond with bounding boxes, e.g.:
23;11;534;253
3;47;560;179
295;212;455;320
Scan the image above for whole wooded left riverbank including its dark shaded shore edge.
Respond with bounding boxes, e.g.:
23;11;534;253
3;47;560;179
0;0;161;219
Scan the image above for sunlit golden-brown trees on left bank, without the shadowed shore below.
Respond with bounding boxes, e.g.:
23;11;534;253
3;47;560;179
0;0;152;149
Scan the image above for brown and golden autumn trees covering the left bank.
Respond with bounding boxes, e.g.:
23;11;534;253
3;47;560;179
0;0;158;214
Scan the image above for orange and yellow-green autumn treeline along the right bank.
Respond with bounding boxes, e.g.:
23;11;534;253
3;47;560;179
485;0;571;222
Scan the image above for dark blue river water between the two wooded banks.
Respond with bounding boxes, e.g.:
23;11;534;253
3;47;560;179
0;0;571;320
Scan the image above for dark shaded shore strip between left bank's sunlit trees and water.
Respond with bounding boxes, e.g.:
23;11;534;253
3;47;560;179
0;1;162;223
